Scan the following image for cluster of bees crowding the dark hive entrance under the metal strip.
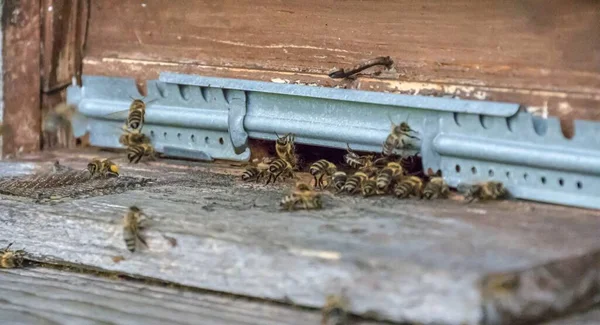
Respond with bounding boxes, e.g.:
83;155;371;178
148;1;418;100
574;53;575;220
237;117;508;210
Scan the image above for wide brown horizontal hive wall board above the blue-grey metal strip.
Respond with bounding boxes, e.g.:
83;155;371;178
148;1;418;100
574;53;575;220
87;0;600;94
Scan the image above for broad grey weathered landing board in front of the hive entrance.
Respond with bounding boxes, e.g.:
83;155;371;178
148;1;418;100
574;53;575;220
0;155;600;324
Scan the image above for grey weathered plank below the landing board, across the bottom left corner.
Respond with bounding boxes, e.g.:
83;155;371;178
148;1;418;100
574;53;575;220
0;268;384;325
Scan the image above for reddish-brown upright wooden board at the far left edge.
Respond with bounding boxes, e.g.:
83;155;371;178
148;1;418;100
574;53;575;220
2;0;41;155
